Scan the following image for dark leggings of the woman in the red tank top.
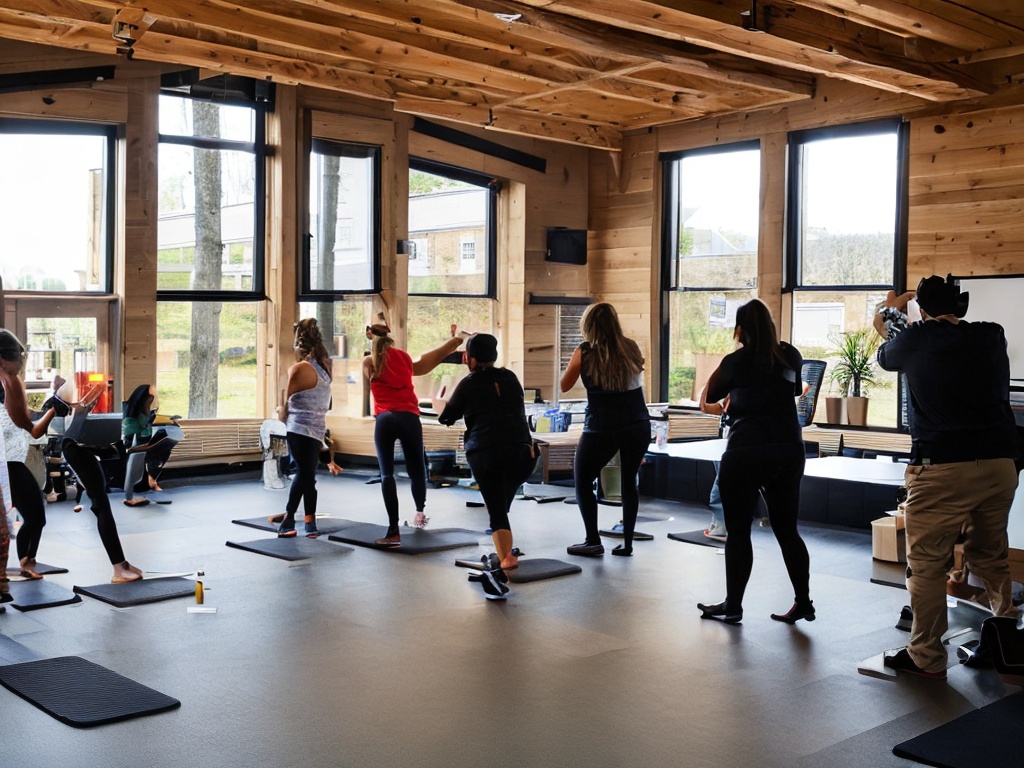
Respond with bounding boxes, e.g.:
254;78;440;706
374;411;427;536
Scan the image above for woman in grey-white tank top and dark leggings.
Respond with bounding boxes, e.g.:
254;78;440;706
278;317;341;539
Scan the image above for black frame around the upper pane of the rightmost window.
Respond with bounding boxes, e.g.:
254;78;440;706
782;118;910;295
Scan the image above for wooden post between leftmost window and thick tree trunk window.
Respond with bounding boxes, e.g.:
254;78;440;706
114;78;160;400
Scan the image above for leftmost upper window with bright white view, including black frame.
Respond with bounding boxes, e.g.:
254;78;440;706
0;118;116;293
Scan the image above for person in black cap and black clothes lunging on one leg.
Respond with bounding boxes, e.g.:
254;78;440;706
437;334;536;599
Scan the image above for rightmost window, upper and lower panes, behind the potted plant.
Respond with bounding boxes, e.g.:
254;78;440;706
786;121;905;426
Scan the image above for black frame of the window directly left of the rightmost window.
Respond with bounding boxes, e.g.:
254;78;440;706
658;138;763;402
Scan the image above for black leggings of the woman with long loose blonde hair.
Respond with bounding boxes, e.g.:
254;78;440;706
572;421;650;549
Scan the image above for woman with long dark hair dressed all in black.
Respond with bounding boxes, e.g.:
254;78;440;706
697;299;814;624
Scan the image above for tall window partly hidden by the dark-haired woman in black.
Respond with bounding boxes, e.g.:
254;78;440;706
662;142;761;402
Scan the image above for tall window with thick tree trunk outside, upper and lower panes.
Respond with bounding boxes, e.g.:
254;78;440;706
157;94;266;419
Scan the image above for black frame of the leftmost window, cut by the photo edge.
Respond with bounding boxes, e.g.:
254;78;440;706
0;117;121;298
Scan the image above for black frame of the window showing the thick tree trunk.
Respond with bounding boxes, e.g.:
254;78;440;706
157;89;271;303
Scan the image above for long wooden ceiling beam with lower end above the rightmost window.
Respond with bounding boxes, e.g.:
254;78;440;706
512;0;991;101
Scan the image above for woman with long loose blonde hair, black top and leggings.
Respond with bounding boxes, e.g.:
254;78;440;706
561;302;650;557
